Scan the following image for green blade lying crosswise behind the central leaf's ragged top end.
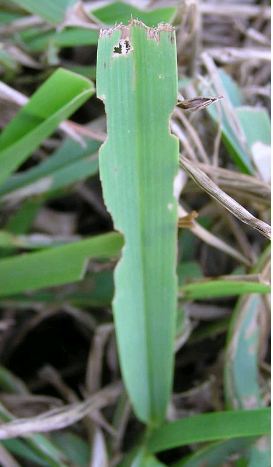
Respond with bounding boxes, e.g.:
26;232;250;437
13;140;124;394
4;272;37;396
92;2;176;26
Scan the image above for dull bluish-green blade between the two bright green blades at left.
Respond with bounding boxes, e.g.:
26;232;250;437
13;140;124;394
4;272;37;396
0;138;100;198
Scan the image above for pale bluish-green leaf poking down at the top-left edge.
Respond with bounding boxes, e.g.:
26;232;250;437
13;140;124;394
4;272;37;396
9;0;76;24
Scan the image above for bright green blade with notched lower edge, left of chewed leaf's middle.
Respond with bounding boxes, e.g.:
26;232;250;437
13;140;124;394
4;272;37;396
0;233;122;297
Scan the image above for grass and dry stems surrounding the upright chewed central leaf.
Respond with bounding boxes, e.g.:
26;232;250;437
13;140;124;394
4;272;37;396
0;0;270;467
